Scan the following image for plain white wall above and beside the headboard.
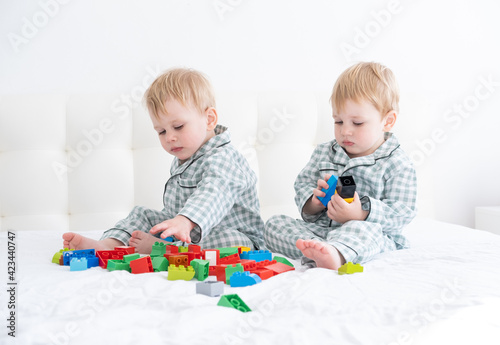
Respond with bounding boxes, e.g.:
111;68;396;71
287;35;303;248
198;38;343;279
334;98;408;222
0;0;500;226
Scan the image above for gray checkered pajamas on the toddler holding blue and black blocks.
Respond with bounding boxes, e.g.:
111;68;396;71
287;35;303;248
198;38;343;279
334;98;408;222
264;133;417;263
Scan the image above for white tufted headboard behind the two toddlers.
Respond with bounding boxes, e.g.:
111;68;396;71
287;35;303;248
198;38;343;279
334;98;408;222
0;92;426;231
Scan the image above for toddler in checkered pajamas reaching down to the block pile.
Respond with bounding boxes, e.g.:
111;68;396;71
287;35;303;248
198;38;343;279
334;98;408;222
63;69;264;254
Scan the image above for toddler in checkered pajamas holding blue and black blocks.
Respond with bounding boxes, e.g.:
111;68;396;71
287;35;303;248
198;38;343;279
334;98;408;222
264;63;417;270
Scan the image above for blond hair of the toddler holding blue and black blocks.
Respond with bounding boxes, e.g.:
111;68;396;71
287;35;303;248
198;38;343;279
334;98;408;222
330;62;399;116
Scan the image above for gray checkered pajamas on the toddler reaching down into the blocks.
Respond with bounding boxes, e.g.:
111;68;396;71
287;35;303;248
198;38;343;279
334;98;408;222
101;125;264;249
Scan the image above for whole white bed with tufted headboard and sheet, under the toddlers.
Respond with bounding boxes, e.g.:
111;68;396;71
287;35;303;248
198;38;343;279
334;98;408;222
0;92;500;345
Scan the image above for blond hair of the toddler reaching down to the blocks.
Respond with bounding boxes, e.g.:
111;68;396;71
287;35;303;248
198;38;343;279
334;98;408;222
144;68;215;118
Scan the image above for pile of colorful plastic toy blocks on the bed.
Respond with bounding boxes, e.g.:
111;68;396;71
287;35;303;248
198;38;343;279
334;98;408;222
52;242;295;287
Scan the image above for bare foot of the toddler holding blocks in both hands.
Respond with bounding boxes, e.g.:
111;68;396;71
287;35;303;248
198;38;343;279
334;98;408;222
295;239;345;270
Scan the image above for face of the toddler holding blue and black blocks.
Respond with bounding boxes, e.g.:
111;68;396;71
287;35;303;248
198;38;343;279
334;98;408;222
333;100;396;158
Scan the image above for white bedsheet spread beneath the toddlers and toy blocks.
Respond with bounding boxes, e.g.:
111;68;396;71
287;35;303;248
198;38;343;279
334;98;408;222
0;219;500;345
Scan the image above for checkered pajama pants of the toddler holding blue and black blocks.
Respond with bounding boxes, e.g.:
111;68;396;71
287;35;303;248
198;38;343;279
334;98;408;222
264;215;397;263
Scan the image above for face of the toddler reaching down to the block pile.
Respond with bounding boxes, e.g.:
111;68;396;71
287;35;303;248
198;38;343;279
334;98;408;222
150;100;217;163
